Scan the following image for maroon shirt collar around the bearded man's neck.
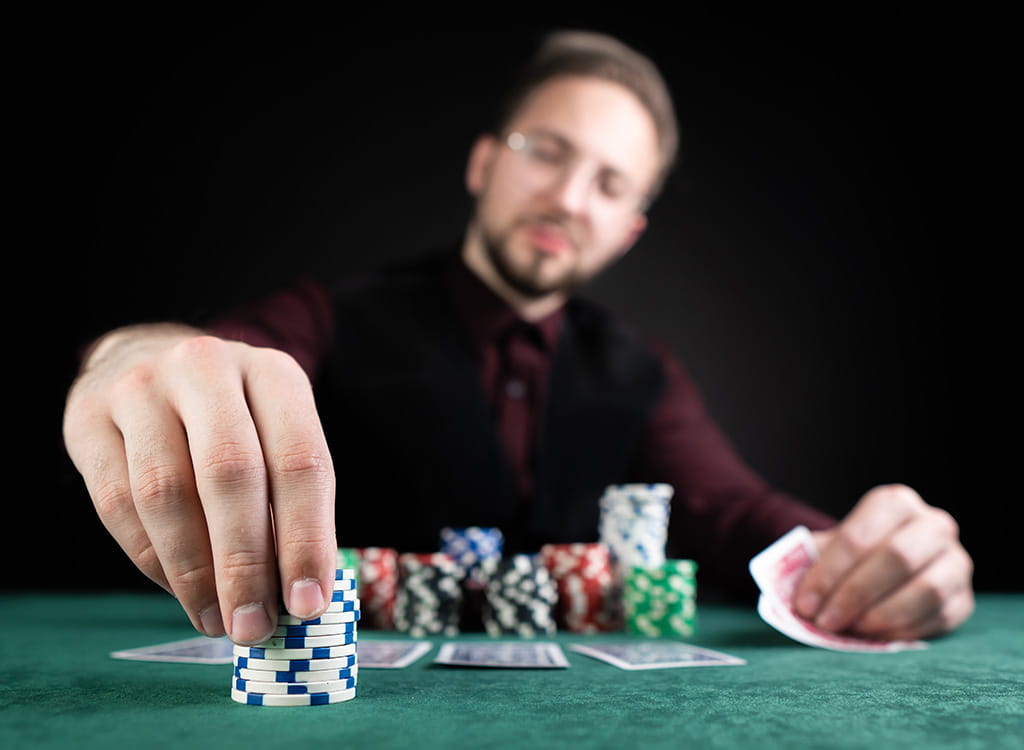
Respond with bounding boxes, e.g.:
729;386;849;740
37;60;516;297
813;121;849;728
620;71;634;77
444;250;564;353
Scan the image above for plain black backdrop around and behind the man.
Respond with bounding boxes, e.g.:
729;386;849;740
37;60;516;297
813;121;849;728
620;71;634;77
3;3;1020;589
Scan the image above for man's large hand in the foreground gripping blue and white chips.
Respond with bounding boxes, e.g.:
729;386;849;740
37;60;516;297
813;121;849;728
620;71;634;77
63;325;337;643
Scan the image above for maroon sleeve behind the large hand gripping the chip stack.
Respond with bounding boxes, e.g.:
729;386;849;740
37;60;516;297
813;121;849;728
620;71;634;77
204;280;334;383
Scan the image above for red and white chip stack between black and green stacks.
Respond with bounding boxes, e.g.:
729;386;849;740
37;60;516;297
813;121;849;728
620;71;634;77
541;543;616;633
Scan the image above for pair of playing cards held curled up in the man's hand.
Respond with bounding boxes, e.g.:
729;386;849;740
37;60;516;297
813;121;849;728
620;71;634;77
750;526;928;653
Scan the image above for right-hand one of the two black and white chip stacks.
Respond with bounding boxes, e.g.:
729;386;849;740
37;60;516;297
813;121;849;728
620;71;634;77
483;554;558;637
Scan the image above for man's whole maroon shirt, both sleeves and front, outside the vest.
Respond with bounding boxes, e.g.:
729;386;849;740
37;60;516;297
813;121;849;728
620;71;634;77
208;262;835;591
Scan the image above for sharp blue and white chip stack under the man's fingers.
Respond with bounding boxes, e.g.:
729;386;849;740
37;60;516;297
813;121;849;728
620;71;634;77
231;569;359;706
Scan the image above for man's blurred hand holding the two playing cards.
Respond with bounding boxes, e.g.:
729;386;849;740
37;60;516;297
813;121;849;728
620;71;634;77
795;485;974;640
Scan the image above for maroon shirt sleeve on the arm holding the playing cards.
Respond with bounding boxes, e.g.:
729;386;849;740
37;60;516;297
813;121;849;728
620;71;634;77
636;342;835;595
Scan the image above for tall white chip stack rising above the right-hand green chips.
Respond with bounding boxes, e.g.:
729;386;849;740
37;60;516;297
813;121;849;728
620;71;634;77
598;484;674;629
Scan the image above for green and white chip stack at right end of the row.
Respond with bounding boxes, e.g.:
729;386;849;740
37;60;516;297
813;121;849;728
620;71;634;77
623;559;696;637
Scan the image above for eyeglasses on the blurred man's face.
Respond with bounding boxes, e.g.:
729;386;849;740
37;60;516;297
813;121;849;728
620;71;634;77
505;130;647;213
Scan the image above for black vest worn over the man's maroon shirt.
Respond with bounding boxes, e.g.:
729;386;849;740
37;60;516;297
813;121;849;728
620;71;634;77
317;255;665;552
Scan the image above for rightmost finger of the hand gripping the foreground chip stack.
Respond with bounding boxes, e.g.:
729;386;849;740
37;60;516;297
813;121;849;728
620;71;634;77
245;349;338;618
